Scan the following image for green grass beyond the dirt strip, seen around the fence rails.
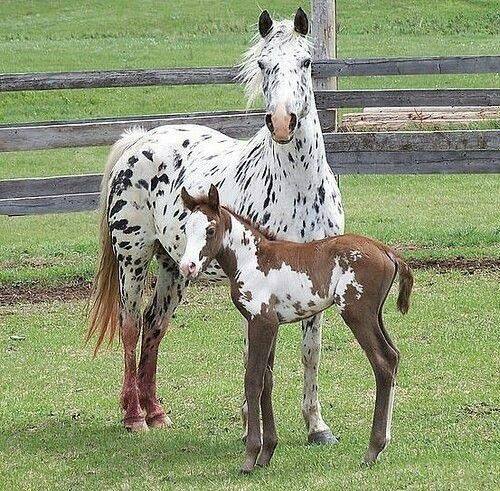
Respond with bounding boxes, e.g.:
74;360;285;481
0;0;500;283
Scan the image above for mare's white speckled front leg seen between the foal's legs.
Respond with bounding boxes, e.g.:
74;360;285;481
302;313;338;444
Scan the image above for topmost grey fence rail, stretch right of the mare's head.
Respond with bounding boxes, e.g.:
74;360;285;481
313;56;500;77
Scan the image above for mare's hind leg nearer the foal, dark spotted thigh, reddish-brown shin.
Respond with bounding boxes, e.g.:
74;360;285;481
139;250;186;427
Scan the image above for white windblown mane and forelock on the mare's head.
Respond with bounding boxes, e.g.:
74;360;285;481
237;20;311;107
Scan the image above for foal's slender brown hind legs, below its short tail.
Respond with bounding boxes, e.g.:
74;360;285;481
342;305;399;464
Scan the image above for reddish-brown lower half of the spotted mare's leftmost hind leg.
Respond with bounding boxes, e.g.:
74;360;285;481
120;313;148;431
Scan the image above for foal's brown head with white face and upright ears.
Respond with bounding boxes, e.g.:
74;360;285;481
179;184;225;279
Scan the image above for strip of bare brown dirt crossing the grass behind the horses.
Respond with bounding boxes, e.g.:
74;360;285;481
0;258;500;306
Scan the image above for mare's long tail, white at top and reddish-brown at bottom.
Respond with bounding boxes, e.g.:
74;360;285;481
86;128;145;355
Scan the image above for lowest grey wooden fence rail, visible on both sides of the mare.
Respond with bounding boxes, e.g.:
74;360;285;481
0;130;500;215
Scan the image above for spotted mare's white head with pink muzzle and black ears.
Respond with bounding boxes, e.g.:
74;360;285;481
241;8;314;143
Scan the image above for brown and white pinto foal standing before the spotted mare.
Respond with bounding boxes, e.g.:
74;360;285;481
180;185;413;472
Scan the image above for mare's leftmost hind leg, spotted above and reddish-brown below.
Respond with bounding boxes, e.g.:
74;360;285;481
117;247;152;431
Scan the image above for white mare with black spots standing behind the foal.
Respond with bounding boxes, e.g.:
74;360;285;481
89;9;344;442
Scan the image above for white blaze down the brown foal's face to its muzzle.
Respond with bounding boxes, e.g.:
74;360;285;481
179;211;213;278
